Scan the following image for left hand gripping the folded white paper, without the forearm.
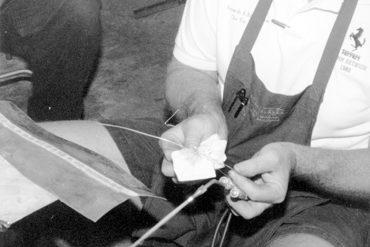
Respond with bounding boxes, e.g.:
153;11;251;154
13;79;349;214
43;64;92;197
160;113;227;178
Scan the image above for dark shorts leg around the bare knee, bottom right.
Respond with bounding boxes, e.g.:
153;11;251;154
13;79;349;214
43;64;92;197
270;203;370;247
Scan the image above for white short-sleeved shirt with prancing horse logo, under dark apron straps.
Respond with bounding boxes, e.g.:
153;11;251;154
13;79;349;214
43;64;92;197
174;0;370;149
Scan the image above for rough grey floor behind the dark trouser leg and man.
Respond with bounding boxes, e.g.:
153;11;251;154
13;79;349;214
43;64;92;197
0;0;183;120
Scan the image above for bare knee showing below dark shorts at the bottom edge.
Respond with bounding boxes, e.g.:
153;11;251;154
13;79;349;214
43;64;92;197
268;233;335;247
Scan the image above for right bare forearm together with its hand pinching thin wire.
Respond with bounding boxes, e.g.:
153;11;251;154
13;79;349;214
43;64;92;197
228;143;370;219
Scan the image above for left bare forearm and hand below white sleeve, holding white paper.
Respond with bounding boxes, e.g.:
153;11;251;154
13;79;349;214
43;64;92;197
160;58;227;177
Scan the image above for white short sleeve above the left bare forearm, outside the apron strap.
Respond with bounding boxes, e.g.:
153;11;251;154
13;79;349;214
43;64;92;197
173;0;219;71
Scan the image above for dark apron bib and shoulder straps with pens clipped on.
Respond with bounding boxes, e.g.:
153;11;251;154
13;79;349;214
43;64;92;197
223;0;356;164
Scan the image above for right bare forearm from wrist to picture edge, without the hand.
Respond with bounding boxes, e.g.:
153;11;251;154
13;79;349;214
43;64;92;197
291;145;370;202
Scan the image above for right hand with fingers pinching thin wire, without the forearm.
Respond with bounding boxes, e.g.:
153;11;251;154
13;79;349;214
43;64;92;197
227;143;296;219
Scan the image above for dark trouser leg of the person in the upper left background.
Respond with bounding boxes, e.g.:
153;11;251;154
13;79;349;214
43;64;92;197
0;0;101;121
